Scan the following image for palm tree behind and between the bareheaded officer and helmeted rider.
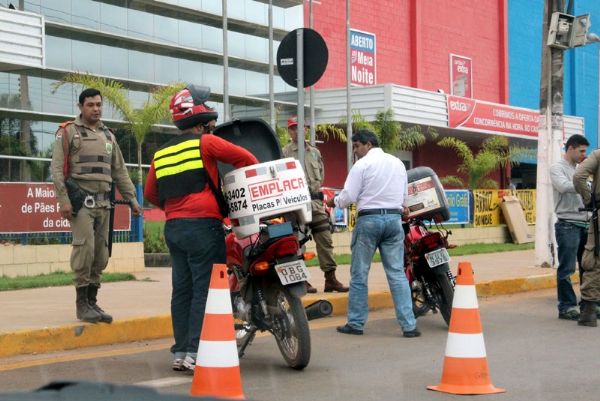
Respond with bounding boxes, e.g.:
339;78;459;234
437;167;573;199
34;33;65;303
52;73;185;187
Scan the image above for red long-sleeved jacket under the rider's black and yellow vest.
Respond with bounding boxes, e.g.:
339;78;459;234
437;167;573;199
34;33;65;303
144;134;258;220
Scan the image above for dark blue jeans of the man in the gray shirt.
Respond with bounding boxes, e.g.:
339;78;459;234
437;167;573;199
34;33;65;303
554;220;587;313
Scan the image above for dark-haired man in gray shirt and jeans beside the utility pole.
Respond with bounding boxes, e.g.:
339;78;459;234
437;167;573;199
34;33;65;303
550;135;590;320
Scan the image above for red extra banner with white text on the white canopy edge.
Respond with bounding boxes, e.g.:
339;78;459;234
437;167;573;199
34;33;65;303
447;95;540;139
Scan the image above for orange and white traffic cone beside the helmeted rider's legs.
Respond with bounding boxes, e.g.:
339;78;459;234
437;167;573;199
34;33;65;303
190;264;245;400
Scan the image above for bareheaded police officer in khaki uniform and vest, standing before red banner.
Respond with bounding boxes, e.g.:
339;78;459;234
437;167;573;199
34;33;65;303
51;88;141;323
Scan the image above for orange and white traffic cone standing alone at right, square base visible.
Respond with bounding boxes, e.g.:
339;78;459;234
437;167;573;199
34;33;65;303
427;262;506;394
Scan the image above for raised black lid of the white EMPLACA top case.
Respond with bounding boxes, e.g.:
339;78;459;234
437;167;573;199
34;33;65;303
213;118;283;177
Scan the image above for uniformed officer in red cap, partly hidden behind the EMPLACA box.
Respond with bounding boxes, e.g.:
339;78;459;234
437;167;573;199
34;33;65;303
283;117;348;294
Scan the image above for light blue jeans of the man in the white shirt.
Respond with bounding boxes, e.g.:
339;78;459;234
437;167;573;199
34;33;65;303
348;214;417;331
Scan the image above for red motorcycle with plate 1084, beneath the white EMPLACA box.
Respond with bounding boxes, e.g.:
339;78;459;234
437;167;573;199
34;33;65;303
225;220;316;370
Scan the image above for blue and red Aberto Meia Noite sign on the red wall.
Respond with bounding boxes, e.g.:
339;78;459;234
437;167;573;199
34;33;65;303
350;29;377;85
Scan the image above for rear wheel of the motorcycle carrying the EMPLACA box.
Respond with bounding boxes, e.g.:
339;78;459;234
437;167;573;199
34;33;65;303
272;287;311;370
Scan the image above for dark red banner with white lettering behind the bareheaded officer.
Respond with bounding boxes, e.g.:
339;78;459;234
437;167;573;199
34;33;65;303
0;182;131;233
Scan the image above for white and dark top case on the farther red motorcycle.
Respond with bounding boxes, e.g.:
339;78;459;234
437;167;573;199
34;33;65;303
405;166;450;223
